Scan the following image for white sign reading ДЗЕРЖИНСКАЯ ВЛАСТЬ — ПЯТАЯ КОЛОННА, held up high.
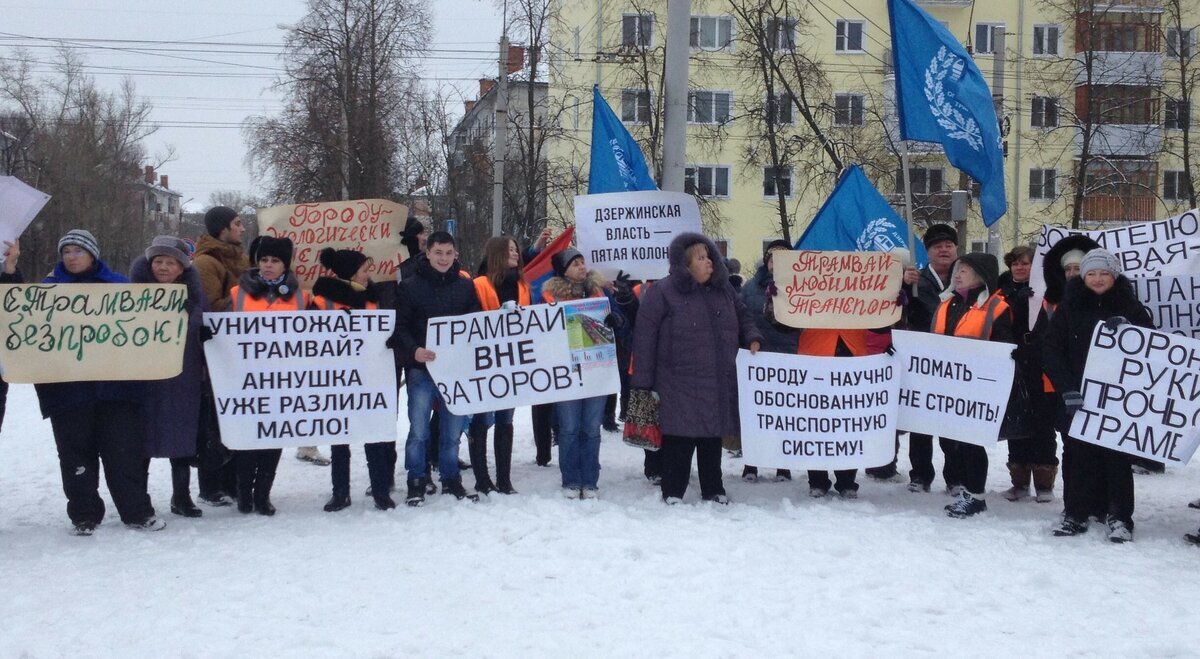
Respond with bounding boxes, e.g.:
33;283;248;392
575;190;701;280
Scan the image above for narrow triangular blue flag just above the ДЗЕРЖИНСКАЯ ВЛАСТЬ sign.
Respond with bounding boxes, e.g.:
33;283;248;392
588;86;659;194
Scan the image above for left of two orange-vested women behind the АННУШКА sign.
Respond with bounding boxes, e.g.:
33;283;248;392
229;235;311;516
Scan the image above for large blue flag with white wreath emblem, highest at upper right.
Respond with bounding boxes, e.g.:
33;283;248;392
888;0;1008;227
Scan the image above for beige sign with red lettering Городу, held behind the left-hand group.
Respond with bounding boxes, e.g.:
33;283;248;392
258;199;408;288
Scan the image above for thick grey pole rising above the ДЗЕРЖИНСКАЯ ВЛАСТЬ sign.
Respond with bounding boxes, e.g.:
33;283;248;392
662;0;691;192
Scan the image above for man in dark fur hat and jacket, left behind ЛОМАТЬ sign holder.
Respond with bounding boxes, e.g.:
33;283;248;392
908;224;960;492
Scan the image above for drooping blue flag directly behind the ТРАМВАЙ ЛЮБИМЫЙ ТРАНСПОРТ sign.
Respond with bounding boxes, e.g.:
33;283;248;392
796;164;929;268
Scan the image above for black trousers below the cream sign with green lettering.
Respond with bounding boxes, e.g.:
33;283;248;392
50;401;154;525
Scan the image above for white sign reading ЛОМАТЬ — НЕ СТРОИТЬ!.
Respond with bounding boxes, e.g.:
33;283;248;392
892;330;1015;447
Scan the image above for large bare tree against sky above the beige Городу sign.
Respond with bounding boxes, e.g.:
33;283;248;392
244;0;430;203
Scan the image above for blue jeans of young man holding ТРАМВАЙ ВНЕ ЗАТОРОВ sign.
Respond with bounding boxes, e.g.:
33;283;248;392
404;369;467;483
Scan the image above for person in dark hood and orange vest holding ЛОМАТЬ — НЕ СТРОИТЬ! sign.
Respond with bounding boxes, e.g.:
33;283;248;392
932;252;1013;519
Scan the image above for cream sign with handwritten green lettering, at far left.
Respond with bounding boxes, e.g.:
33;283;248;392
0;283;187;383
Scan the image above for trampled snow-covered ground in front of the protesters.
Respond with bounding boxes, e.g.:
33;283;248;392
0;385;1200;658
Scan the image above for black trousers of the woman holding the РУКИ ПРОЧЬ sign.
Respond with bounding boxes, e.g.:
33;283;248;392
1063;437;1133;528
